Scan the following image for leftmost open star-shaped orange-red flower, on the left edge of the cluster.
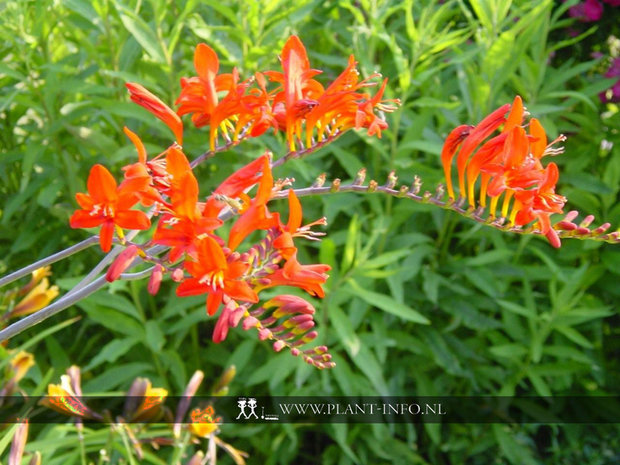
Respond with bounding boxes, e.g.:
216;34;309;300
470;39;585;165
70;165;151;252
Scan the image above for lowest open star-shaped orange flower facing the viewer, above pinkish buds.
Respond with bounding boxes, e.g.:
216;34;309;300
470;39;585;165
177;236;258;315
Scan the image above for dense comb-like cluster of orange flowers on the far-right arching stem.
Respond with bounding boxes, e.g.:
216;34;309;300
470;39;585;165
441;96;566;247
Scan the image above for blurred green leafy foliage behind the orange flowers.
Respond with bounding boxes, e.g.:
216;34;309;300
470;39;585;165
0;0;620;464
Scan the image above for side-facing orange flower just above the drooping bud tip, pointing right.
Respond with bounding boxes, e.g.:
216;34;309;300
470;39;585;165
256;252;331;298
